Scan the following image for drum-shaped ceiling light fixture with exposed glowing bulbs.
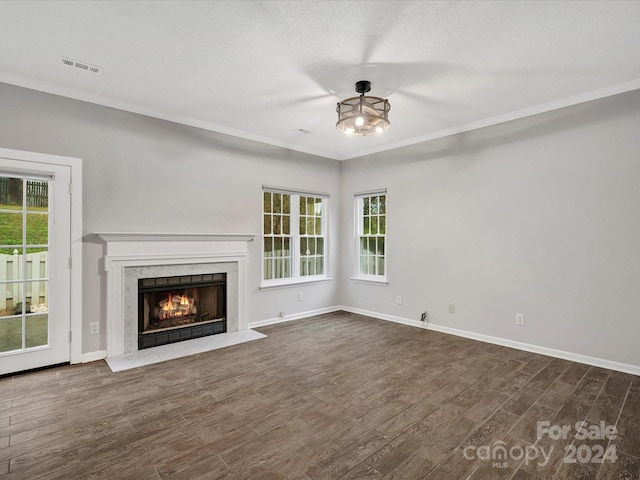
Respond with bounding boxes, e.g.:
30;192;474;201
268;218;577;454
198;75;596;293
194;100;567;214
336;80;391;135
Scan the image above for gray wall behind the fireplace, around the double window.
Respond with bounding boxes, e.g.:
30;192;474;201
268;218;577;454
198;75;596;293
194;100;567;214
0;83;340;352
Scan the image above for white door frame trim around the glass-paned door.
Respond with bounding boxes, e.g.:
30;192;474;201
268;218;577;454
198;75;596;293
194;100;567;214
0;148;82;363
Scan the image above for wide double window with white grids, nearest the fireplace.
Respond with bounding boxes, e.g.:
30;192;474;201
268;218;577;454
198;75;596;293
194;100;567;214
262;187;328;286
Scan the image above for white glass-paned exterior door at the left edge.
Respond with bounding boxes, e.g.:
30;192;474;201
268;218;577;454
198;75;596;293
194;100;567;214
0;157;71;375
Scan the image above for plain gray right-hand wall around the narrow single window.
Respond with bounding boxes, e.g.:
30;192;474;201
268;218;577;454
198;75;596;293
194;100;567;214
340;91;640;366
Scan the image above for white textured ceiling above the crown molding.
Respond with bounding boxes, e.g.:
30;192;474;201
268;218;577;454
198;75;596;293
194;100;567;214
0;0;640;159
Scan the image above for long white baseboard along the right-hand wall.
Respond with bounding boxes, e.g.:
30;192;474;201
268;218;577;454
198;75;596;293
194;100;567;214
339;305;640;375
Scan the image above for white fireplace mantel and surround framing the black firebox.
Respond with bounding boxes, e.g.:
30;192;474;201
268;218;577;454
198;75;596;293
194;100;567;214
95;232;255;358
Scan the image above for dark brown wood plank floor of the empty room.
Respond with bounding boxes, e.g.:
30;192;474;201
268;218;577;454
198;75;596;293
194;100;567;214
0;312;640;480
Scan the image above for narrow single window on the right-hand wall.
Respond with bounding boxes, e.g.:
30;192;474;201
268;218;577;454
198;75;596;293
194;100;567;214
356;190;387;282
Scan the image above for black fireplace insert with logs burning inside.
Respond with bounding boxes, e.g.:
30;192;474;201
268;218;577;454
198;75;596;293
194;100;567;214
138;273;227;350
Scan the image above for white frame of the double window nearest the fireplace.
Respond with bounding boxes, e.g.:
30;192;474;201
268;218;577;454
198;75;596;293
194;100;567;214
260;185;332;289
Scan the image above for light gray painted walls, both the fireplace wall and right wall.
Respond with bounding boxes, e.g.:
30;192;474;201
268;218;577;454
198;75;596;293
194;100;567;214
0;84;640;366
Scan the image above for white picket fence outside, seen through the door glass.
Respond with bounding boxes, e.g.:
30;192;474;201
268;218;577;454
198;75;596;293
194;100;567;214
0;252;48;314
